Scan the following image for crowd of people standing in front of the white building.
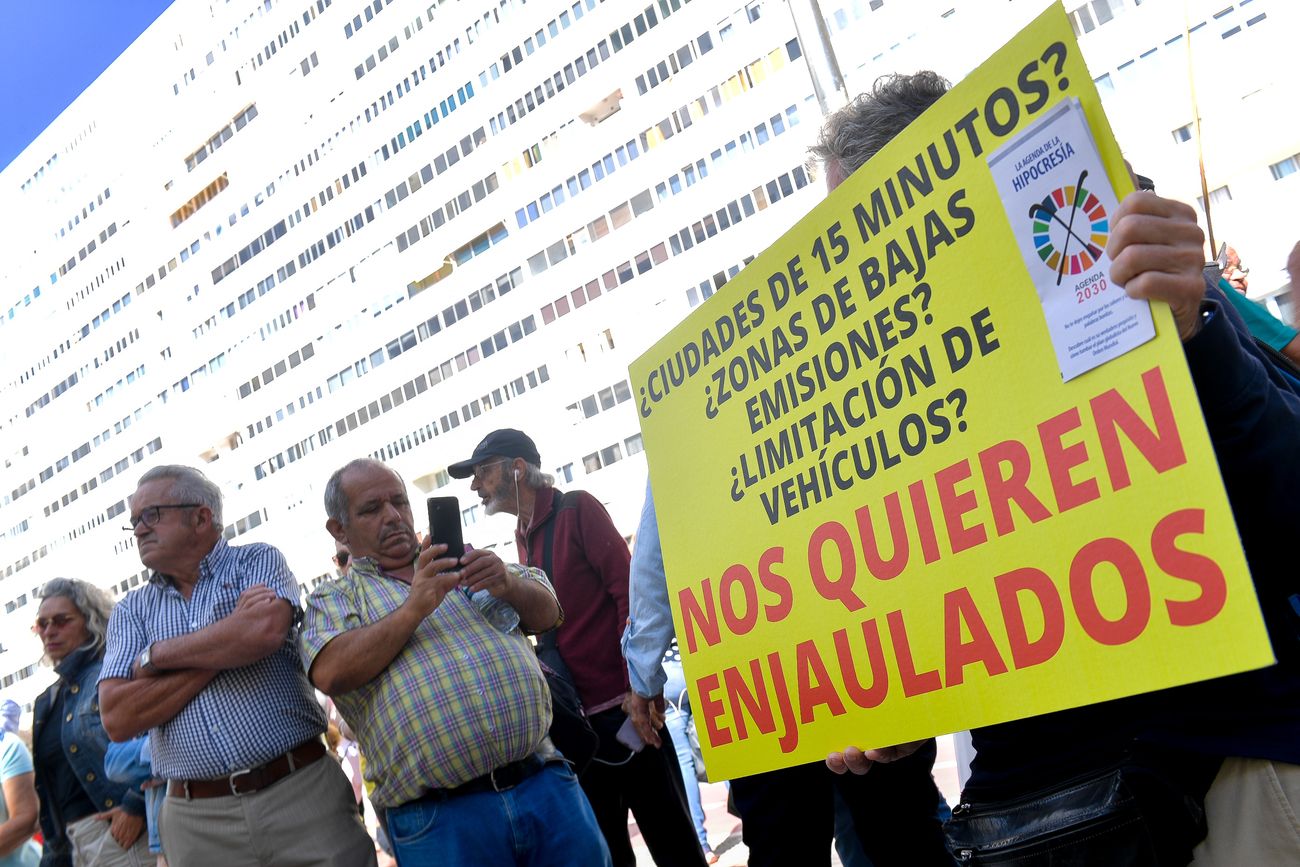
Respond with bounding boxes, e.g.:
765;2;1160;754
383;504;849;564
0;73;1300;867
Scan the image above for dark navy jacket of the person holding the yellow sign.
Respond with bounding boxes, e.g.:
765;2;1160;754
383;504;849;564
967;289;1300;799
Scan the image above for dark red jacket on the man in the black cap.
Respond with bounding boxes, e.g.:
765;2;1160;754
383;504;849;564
515;487;632;711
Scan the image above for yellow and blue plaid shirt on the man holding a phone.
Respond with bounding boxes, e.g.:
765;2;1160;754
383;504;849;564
300;558;554;807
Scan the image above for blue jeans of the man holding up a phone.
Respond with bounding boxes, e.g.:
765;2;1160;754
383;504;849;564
387;762;610;867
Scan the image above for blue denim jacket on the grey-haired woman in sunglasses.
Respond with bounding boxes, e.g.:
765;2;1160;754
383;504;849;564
31;647;144;866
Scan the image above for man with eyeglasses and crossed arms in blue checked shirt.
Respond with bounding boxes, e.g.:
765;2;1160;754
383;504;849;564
99;467;376;867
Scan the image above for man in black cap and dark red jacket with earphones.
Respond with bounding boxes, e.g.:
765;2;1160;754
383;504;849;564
447;428;705;867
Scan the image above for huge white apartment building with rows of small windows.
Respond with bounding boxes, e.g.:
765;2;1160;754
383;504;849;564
0;0;1300;703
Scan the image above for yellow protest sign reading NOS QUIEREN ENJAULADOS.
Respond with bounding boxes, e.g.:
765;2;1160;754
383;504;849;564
632;6;1273;779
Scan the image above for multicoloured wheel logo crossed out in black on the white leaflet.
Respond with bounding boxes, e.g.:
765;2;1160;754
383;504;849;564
1030;170;1110;286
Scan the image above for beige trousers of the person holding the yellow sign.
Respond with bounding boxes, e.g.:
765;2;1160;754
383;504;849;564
1192;759;1300;867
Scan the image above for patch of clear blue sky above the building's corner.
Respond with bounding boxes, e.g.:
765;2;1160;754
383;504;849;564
0;0;172;169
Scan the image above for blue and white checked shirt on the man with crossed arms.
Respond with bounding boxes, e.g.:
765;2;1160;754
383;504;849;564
99;539;325;780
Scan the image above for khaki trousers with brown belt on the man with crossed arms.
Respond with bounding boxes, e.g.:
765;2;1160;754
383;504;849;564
159;755;376;867
